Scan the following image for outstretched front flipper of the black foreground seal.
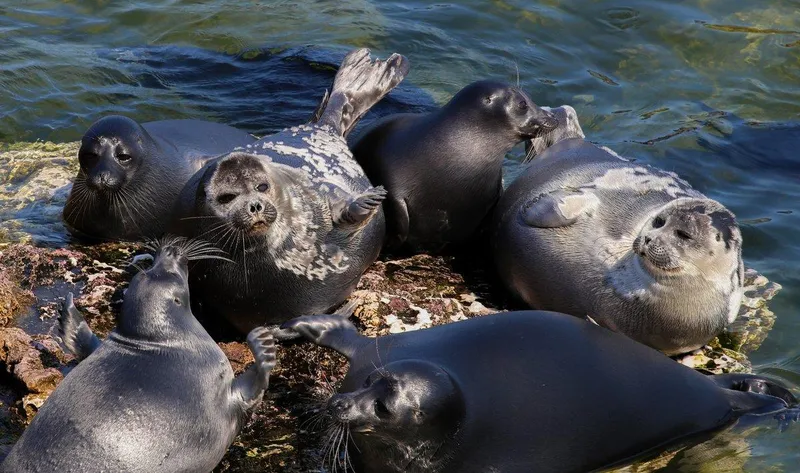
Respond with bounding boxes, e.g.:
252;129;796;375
281;314;368;359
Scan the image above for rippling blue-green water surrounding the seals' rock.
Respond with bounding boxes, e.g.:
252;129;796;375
0;0;800;471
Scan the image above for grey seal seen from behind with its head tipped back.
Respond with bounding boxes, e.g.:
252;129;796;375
0;242;275;473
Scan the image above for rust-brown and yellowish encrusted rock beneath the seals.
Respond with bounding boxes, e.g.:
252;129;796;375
0;143;780;472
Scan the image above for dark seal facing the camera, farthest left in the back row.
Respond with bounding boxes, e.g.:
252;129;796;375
63;115;256;241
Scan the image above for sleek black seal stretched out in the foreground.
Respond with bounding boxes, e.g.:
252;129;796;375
276;311;796;473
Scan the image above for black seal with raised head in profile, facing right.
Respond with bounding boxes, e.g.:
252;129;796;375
352;81;557;251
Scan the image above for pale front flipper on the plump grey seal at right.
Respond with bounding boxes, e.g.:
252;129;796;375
520;189;600;228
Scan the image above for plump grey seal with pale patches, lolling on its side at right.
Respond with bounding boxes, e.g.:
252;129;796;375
492;139;744;354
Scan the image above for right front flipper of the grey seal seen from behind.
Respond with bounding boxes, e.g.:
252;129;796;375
231;327;276;412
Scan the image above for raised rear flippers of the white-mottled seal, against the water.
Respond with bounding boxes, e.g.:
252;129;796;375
312;48;409;137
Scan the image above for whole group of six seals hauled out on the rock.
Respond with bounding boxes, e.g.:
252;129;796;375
6;42;797;473
